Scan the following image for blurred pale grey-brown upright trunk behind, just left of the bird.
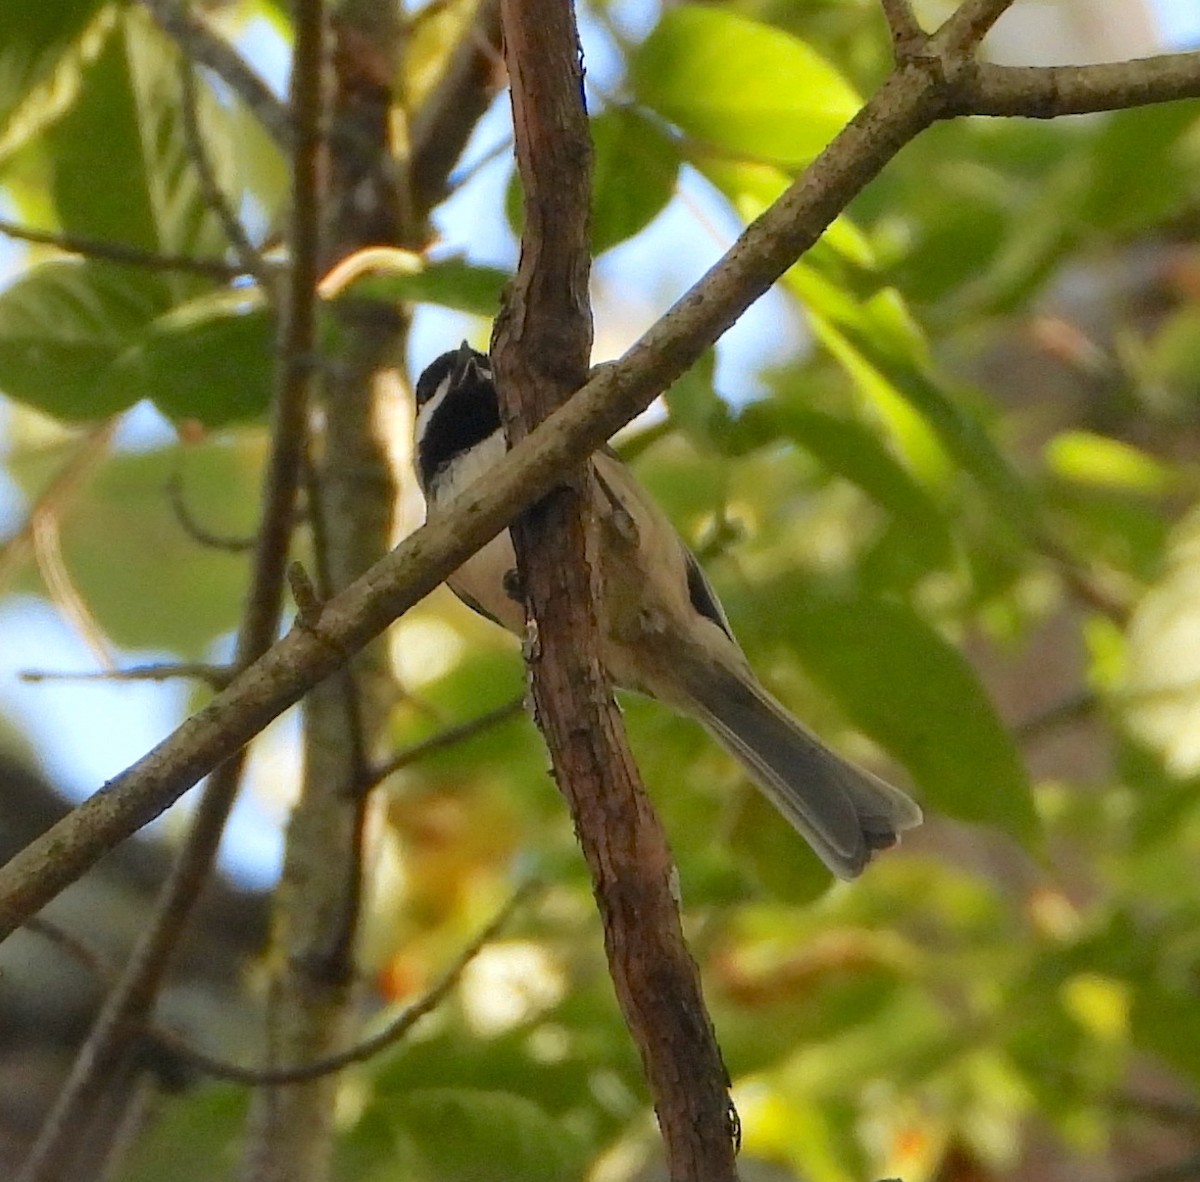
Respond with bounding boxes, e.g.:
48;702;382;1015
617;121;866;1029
242;0;407;1182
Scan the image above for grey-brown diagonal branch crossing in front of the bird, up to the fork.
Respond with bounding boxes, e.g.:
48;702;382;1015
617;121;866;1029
0;70;984;937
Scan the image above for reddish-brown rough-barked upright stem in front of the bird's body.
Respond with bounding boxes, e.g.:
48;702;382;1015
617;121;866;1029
494;0;736;1182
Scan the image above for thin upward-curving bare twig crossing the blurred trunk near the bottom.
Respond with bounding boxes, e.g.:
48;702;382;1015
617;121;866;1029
150;881;542;1087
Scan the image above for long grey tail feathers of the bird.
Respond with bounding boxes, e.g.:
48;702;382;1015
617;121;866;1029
691;670;922;878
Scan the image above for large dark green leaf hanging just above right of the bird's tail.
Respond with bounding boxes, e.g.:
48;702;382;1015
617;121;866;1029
779;592;1037;844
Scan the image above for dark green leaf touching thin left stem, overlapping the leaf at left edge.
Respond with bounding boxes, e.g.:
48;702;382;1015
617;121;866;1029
101;292;275;427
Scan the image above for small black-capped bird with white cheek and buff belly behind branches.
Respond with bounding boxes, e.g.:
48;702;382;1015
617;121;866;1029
416;341;922;878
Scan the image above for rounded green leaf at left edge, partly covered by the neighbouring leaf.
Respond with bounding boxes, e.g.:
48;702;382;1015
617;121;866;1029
0;260;169;420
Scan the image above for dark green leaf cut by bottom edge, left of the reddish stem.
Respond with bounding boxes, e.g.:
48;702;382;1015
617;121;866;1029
388;1087;588;1182
